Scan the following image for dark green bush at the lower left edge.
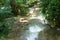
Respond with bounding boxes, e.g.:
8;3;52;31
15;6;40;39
0;22;10;38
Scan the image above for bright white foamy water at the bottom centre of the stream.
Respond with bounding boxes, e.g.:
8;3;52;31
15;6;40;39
27;25;44;40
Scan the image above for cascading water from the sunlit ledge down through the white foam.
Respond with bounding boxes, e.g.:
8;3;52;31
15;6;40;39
20;8;46;40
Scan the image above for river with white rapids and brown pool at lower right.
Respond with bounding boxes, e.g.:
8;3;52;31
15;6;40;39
20;8;60;40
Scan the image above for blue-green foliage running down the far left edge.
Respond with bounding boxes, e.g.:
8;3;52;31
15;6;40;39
0;0;14;38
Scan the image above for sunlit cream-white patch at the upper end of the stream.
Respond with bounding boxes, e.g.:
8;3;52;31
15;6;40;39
29;8;48;24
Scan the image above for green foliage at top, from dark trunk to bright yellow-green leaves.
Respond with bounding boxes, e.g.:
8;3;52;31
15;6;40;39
10;0;35;16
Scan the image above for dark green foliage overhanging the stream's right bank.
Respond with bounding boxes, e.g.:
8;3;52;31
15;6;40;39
41;0;60;26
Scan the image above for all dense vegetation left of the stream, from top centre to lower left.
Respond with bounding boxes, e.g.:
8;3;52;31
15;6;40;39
0;0;37;37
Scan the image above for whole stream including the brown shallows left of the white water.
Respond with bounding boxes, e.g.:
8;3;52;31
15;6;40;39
5;7;60;40
